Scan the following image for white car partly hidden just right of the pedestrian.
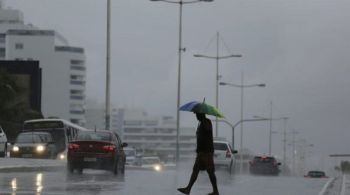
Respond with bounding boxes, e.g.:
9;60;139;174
214;139;237;173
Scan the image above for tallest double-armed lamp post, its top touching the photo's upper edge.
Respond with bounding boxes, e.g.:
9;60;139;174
150;0;214;164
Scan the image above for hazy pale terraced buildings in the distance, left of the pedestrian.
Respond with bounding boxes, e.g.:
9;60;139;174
86;101;196;161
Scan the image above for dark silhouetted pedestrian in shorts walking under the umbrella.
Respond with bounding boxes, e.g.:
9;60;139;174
177;113;219;195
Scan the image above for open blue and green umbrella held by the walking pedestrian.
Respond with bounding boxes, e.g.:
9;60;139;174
180;101;224;118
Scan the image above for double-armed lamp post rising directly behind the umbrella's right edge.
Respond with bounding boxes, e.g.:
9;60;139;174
193;32;242;137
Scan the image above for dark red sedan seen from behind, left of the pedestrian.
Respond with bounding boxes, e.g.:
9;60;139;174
67;130;127;174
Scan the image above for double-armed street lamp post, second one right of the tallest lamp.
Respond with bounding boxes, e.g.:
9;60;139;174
220;79;266;173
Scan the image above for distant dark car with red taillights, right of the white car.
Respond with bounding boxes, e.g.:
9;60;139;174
249;156;281;175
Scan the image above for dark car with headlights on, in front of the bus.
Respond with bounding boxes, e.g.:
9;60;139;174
10;132;57;159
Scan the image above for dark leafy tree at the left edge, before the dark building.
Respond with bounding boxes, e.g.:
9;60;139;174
0;69;43;141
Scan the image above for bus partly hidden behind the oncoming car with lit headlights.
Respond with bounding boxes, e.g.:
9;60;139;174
22;119;87;159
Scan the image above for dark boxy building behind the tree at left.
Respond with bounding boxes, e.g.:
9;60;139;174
0;61;41;112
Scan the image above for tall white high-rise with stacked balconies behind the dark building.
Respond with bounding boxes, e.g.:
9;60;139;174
0;4;86;125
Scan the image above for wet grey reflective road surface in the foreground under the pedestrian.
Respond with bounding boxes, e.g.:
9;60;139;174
0;169;327;195
